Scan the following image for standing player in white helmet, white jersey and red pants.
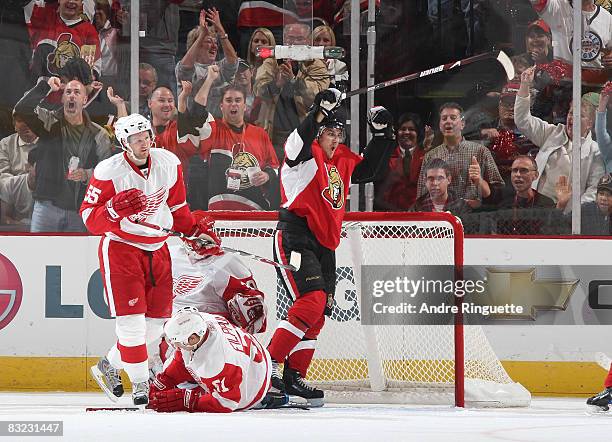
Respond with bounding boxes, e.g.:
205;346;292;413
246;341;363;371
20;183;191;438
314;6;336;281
81;114;220;405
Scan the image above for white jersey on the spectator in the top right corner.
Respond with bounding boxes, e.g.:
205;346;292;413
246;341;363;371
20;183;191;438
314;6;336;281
531;0;612;70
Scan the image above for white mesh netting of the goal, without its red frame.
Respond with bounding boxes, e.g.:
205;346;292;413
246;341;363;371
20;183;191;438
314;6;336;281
216;214;513;402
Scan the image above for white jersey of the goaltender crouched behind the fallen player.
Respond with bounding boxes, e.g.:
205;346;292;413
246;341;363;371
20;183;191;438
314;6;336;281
169;245;257;317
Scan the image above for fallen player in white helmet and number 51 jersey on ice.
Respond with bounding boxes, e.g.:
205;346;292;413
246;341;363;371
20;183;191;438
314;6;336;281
148;307;272;413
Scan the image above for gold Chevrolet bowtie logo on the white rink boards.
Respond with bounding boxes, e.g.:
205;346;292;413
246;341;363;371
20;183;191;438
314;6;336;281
473;267;580;321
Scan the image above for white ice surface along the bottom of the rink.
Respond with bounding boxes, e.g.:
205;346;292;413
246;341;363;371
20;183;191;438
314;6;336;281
0;393;612;442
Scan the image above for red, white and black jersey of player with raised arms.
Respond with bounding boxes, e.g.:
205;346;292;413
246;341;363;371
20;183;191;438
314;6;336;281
280;115;362;250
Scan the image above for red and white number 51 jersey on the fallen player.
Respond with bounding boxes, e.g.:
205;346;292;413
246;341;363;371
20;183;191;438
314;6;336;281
161;313;271;413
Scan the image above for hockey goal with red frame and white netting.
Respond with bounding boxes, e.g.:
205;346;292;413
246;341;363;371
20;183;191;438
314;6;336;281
211;212;530;407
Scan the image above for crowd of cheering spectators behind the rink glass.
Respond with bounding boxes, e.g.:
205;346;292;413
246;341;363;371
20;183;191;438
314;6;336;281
0;0;612;235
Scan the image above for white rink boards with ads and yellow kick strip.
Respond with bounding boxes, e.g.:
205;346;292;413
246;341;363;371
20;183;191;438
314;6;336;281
0;236;612;395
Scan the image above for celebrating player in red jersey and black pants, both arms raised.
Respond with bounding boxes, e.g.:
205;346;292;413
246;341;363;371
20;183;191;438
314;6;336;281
268;89;396;406
